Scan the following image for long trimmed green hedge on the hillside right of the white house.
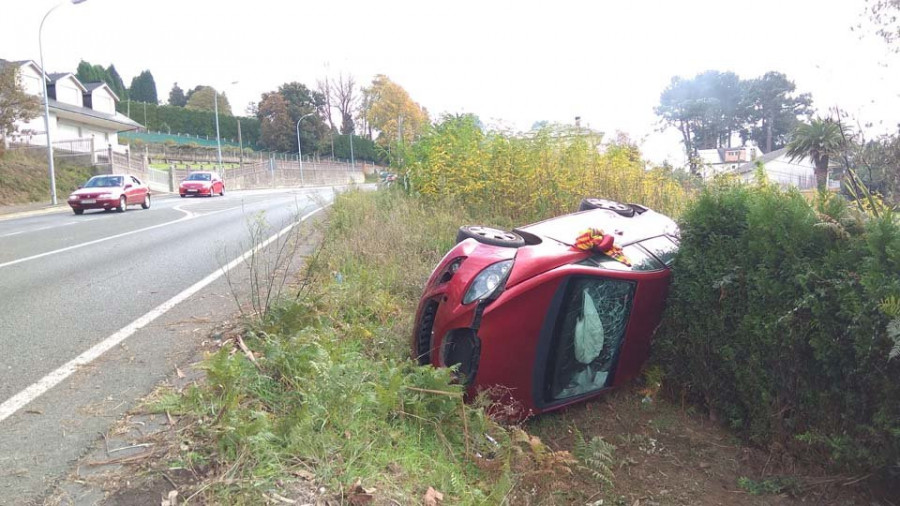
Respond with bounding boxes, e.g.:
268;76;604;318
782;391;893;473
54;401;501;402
116;101;259;149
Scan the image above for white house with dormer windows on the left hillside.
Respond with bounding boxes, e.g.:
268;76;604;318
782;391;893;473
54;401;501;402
0;59;142;152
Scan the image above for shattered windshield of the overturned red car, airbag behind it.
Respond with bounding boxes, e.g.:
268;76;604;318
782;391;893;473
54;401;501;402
544;277;635;402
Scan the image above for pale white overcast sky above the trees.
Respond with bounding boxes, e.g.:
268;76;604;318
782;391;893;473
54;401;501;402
0;0;900;164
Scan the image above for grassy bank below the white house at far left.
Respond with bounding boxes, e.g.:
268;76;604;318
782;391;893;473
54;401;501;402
0;151;91;205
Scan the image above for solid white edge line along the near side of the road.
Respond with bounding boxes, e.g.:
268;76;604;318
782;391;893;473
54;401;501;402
0;204;331;422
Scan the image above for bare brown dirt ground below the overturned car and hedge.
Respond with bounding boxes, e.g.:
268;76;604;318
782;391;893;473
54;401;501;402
511;388;900;506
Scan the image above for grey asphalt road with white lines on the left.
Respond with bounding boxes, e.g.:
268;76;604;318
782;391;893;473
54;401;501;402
0;188;334;504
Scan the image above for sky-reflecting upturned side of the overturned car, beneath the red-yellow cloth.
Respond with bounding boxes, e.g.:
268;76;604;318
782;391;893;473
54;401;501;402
519;209;678;246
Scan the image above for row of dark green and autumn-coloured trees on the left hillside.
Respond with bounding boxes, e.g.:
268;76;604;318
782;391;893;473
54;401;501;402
78;61;429;161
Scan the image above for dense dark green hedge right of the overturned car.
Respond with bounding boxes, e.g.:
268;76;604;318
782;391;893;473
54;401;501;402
653;185;900;472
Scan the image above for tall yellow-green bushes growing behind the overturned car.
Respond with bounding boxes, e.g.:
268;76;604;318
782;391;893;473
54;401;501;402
407;116;690;222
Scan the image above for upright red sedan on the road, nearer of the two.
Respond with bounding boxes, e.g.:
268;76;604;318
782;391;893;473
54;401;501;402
67;174;150;214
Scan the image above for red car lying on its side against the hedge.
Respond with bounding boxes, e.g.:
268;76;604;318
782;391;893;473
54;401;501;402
412;204;678;417
